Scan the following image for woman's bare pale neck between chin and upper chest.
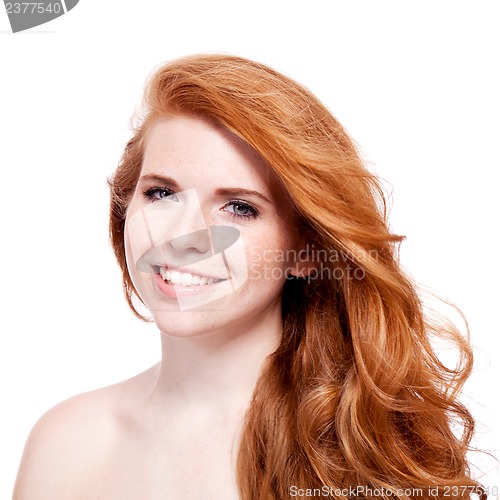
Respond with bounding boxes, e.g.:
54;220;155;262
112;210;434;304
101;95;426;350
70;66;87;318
150;306;282;414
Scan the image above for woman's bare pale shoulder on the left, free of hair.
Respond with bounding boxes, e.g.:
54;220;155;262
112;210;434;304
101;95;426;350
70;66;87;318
13;367;155;500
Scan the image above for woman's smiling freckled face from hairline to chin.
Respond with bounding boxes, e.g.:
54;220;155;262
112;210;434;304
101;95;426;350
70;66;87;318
125;115;296;337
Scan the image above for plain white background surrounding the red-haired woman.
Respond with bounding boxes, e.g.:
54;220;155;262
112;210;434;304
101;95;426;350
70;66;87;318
0;0;500;498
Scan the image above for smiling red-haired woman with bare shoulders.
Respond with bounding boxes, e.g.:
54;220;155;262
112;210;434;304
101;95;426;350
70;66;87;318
14;55;481;500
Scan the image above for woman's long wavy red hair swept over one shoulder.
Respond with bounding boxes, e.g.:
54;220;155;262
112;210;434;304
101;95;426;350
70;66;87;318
110;55;480;500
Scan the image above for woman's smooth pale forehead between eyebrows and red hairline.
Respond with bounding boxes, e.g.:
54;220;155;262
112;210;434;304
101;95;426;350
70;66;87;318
141;115;276;193
